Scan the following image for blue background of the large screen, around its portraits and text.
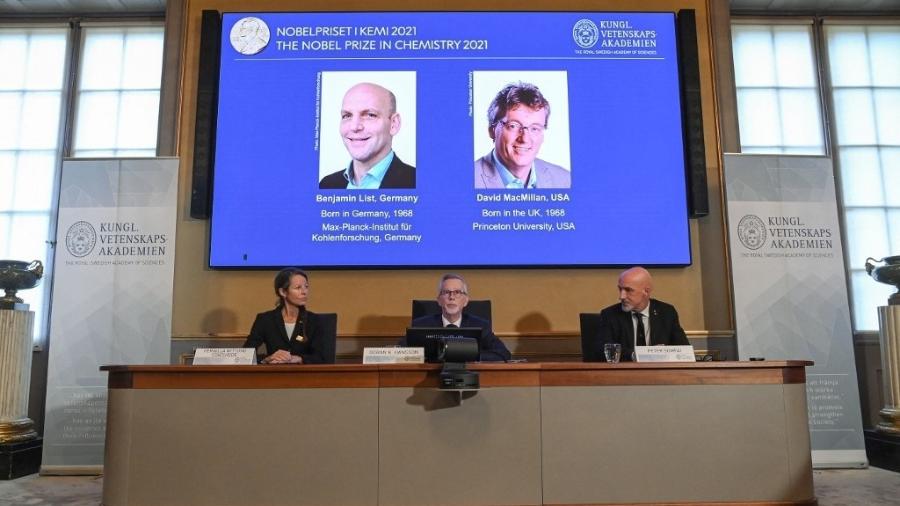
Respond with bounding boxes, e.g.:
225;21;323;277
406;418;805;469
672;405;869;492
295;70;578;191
210;12;691;267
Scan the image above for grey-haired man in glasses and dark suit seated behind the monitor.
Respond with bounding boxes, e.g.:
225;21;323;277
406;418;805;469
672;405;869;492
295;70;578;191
400;274;512;362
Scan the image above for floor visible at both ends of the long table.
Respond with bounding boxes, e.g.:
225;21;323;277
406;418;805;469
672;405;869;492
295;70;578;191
0;467;900;506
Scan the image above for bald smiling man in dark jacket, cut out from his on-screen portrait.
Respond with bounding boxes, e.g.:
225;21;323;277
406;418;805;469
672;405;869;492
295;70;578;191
319;83;416;190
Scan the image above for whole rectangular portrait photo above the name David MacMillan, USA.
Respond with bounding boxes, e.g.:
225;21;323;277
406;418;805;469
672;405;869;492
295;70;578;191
473;71;572;190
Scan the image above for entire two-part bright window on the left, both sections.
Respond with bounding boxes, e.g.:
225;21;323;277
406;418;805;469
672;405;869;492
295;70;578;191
0;21;163;342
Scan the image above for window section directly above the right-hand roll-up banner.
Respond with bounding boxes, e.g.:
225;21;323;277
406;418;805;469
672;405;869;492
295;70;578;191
731;24;825;155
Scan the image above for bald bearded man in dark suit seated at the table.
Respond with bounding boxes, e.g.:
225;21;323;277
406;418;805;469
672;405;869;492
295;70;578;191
583;267;691;361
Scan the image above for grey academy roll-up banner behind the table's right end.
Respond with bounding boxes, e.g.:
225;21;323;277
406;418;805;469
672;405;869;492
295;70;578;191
725;155;867;468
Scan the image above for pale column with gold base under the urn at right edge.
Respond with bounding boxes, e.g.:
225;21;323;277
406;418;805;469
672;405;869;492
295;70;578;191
875;305;900;436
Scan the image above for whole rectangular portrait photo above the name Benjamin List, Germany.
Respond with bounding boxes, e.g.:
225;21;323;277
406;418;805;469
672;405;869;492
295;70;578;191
319;72;416;190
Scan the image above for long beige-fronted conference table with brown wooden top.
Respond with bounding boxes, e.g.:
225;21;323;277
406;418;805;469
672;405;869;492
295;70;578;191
102;361;816;506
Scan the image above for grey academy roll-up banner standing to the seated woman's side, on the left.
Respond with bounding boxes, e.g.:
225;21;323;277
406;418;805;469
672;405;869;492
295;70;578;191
41;158;178;474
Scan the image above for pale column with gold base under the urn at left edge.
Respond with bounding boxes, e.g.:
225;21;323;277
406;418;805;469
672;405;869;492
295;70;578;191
0;306;37;443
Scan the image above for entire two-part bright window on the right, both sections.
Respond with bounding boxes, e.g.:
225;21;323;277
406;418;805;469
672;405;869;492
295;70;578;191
732;20;900;331
